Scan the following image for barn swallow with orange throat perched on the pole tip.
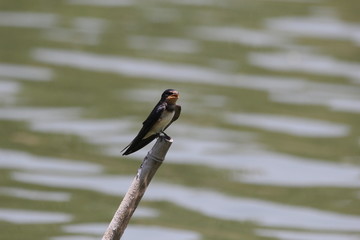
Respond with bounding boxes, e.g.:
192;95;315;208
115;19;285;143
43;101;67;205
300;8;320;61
121;89;181;155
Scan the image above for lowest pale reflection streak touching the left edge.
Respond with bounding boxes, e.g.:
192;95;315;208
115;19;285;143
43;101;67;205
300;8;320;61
0;209;72;224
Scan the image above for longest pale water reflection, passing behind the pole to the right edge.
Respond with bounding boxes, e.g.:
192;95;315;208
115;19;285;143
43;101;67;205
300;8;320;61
13;172;360;231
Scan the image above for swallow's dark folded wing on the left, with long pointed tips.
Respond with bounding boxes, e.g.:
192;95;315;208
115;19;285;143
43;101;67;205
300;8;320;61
121;103;166;155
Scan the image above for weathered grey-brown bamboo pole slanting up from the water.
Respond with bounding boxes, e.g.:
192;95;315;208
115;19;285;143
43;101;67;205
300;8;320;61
102;136;173;240
